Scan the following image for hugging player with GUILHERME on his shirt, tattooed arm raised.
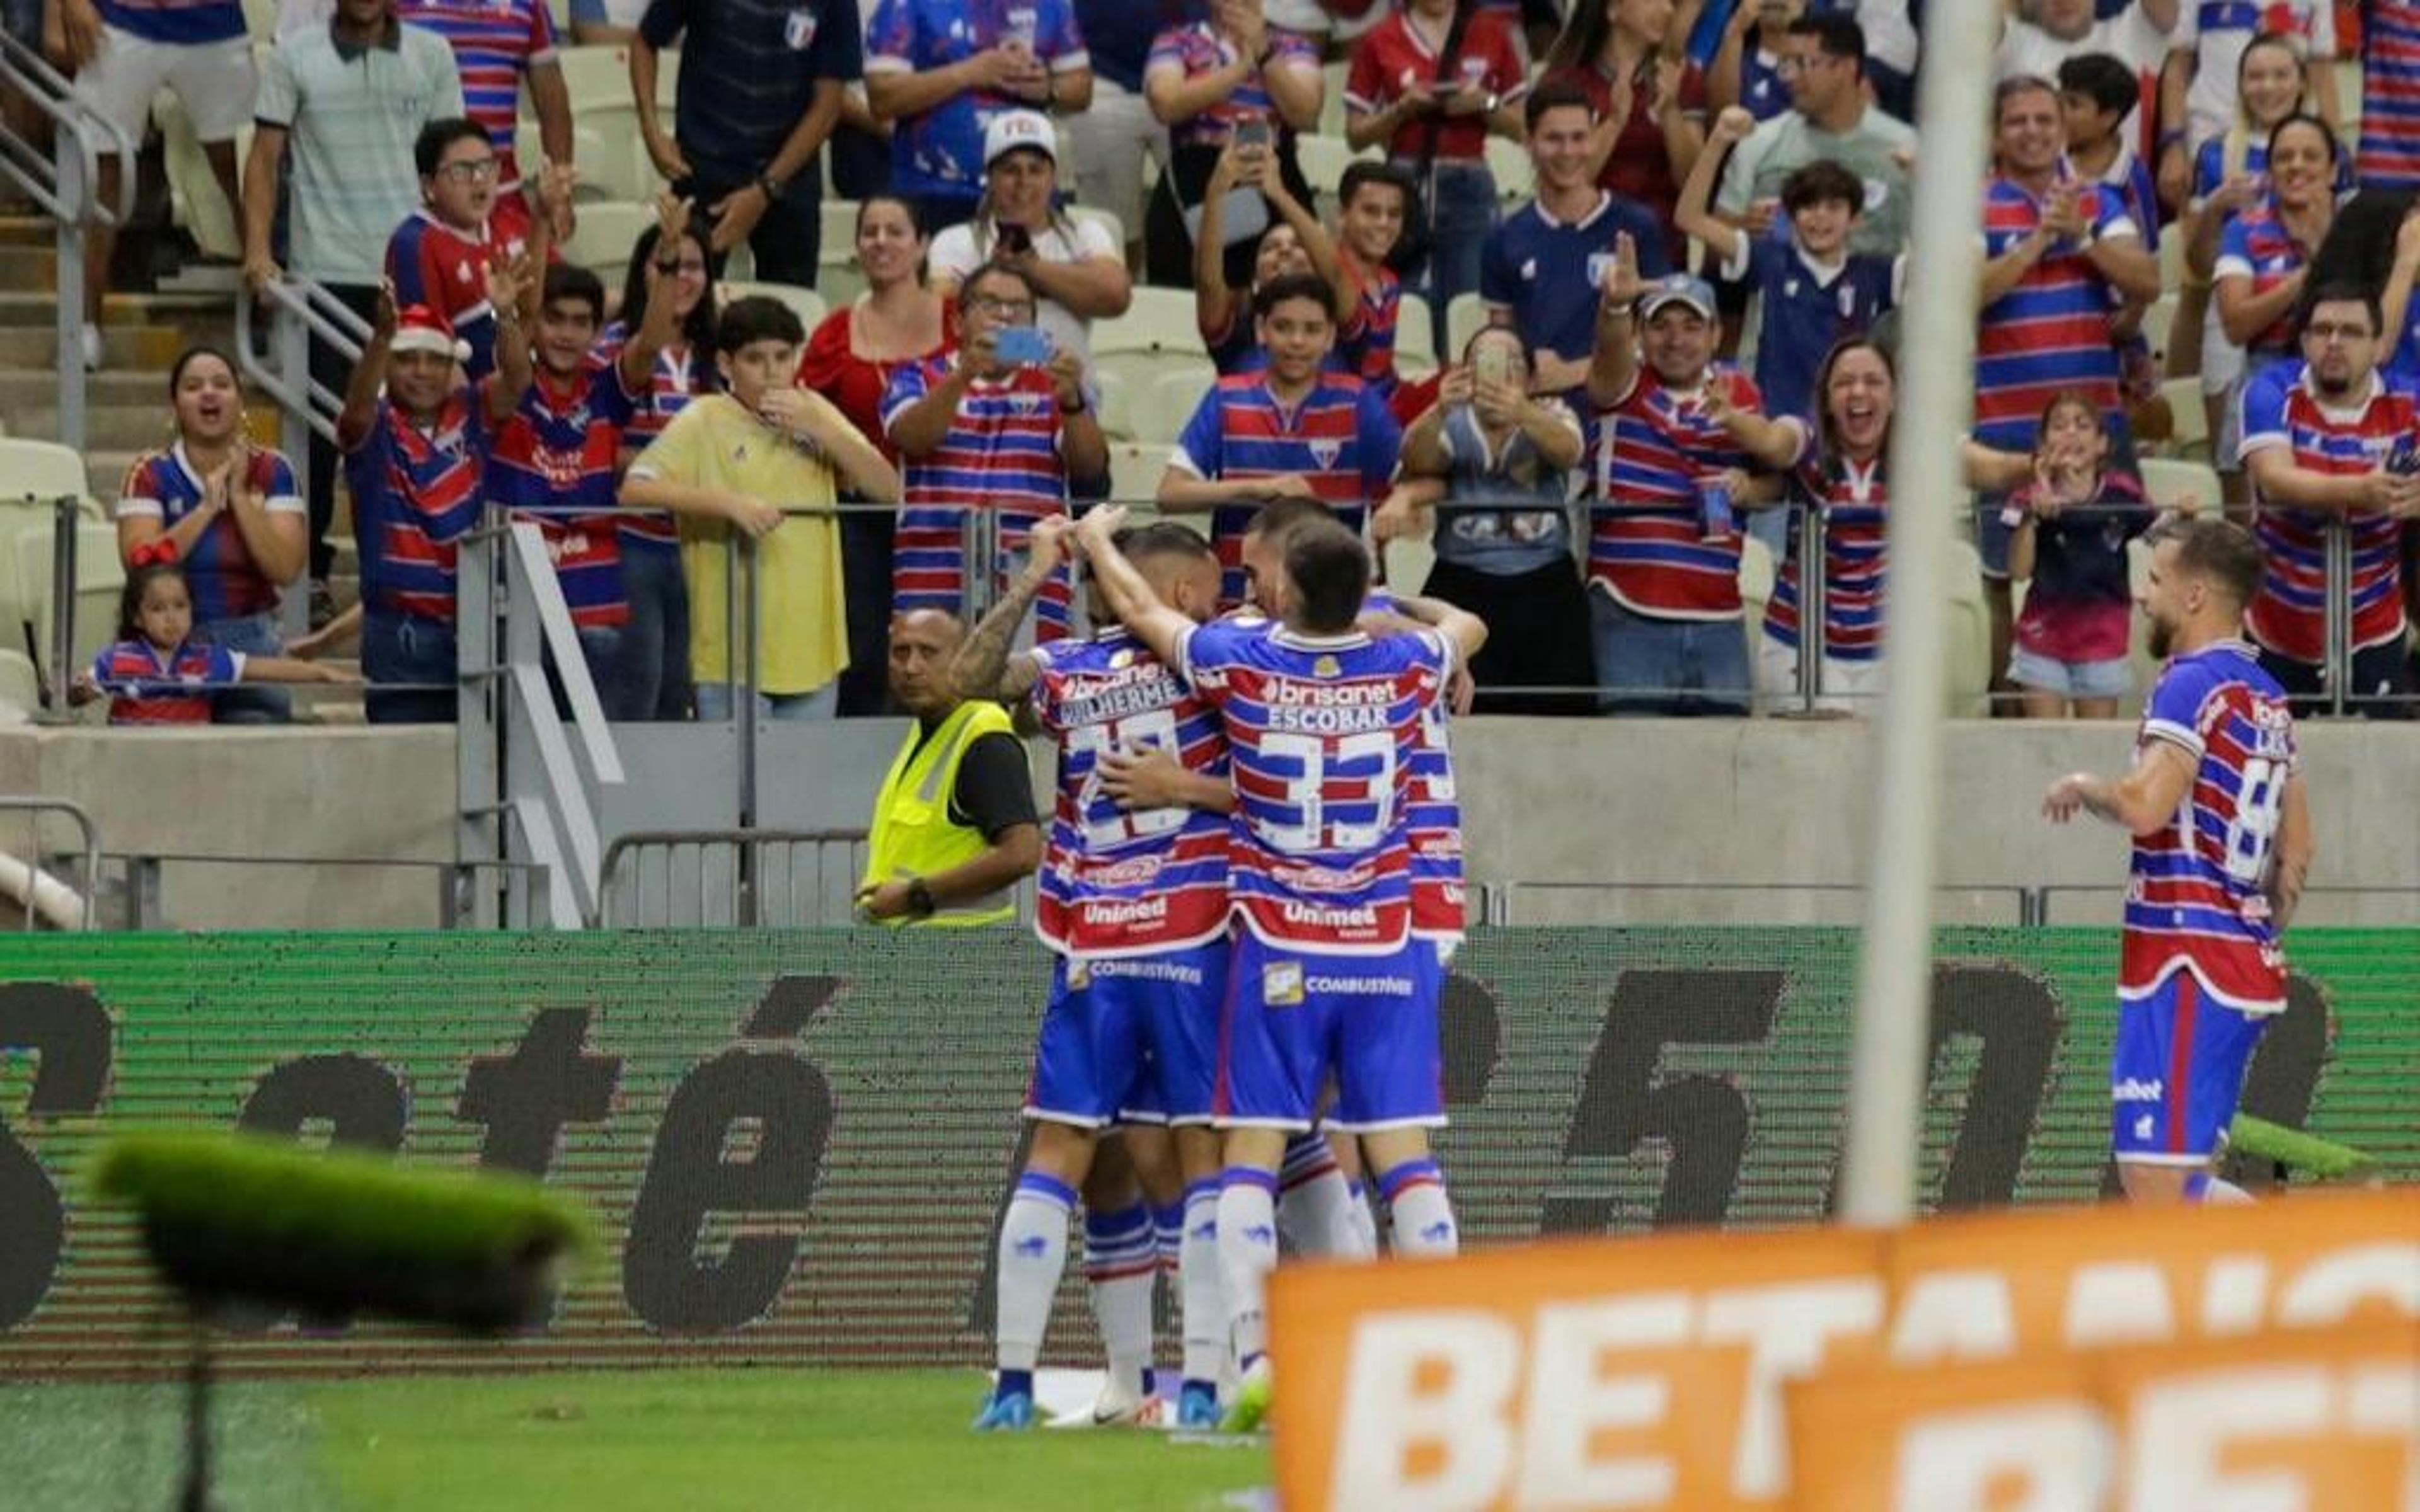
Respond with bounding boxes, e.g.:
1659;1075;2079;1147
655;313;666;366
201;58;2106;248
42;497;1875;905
951;518;1234;1429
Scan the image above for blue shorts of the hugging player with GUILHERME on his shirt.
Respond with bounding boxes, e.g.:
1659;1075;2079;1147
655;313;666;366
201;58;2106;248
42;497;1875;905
1026;941;1227;1130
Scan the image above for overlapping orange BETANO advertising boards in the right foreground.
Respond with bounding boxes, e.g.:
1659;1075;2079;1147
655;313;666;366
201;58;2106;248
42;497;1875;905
1270;1190;2420;1512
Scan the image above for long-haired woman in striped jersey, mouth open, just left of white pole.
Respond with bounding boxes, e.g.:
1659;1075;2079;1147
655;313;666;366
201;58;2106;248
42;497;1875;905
1757;336;2031;714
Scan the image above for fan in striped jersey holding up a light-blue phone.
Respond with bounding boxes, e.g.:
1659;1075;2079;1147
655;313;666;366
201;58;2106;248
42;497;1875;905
881;261;1109;641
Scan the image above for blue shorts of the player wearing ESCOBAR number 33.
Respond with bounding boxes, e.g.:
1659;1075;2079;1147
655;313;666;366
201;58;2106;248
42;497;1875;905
1215;931;1444;1135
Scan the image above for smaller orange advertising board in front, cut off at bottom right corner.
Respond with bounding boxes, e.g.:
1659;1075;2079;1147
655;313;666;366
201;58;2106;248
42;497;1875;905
1786;1323;2420;1512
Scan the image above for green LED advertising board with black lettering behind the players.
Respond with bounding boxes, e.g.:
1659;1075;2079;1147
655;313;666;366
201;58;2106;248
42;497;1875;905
0;929;2420;1374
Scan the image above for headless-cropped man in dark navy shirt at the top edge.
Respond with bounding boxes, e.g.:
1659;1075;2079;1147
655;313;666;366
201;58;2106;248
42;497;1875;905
629;0;864;288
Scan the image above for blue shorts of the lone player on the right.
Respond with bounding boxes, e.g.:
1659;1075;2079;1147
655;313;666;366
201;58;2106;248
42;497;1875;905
2110;970;2275;1166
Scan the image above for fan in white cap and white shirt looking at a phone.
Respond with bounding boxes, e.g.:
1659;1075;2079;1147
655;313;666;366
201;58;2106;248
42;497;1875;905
927;112;1135;377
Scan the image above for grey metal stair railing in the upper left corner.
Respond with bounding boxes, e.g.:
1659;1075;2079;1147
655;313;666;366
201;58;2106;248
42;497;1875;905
0;34;135;450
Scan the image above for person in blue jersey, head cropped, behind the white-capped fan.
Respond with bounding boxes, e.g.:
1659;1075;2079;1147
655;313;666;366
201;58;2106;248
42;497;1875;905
867;0;1092;232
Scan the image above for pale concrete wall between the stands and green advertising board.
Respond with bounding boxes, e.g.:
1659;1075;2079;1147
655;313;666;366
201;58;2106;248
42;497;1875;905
0;718;2420;929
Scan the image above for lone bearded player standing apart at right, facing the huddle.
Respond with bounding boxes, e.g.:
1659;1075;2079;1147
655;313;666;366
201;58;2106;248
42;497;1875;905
2043;518;2311;1202
